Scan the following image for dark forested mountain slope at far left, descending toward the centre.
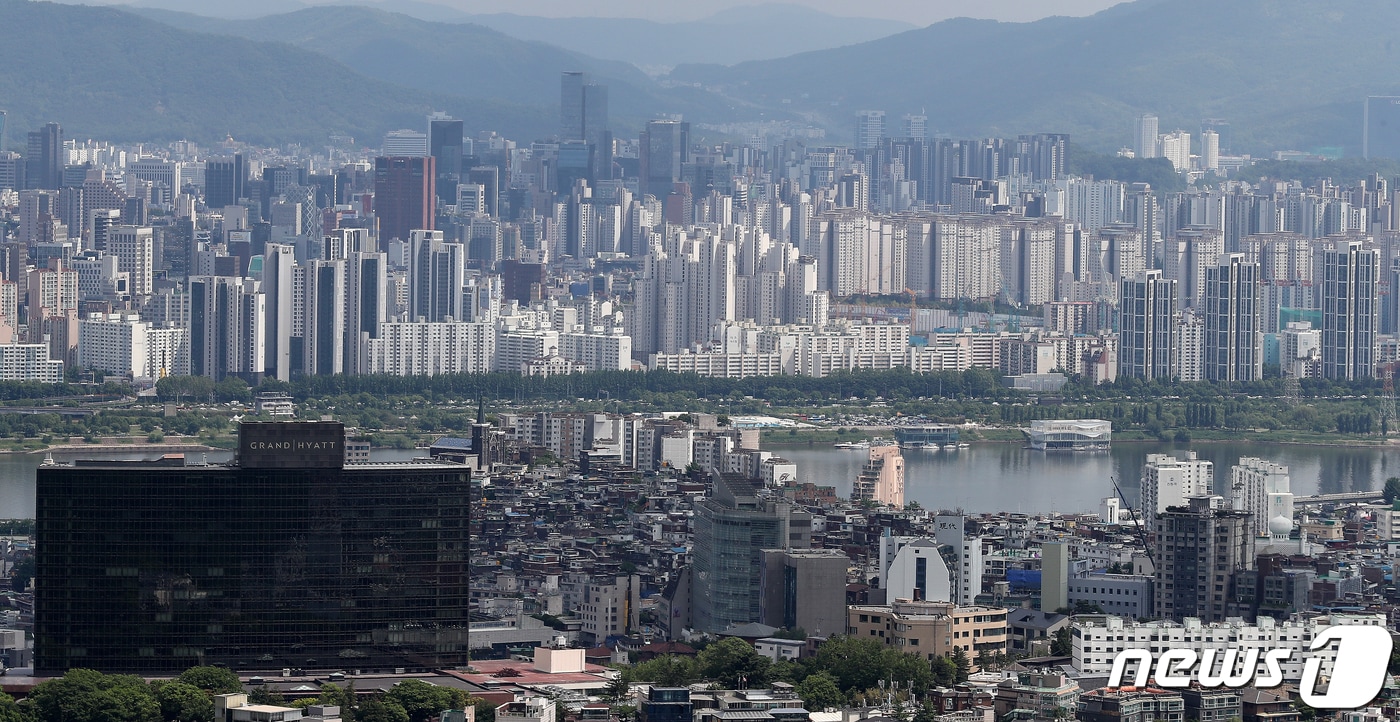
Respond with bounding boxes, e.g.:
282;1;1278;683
0;0;546;147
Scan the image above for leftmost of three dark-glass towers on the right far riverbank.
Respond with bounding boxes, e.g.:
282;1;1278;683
1119;269;1176;379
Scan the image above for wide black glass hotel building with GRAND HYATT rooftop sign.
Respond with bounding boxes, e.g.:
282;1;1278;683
35;423;470;674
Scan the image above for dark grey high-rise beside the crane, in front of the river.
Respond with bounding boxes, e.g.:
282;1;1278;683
1154;497;1254;623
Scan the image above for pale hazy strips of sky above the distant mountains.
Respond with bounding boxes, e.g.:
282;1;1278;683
95;0;1123;25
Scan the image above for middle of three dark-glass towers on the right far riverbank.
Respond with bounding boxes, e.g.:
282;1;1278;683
1204;253;1264;382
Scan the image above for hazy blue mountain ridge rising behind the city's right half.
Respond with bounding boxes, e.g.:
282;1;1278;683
671;0;1400;153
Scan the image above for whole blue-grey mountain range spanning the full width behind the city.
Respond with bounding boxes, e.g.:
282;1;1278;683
8;0;1400;154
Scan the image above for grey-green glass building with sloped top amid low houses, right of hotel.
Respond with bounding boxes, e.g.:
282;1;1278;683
690;473;812;634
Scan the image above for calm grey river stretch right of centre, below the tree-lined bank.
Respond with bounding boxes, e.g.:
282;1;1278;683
769;442;1400;512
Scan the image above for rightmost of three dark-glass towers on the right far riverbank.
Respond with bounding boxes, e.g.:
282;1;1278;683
1320;241;1380;379
